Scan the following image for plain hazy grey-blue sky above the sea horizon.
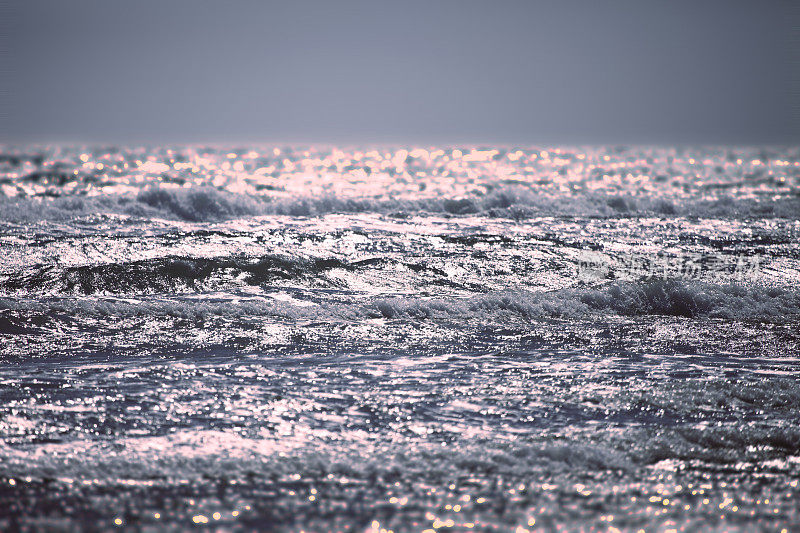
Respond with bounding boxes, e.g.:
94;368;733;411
0;0;800;144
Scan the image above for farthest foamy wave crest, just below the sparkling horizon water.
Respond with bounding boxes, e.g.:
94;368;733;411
0;185;800;223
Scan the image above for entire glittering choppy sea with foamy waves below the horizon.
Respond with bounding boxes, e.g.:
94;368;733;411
0;146;800;532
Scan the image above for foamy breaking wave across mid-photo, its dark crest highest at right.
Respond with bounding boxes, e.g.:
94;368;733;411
0;280;800;328
